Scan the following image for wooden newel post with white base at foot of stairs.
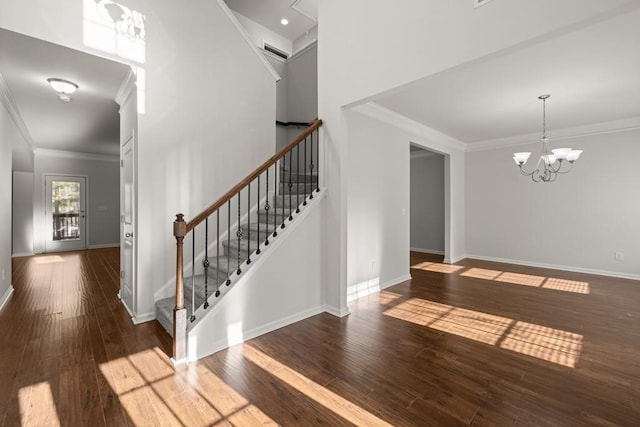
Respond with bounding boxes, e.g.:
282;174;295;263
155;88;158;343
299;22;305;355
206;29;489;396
172;214;187;364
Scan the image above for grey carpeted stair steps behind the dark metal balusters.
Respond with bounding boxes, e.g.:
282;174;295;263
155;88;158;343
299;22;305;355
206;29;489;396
155;171;318;336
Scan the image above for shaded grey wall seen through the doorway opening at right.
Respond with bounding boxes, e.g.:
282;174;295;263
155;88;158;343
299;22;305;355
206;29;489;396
410;154;445;254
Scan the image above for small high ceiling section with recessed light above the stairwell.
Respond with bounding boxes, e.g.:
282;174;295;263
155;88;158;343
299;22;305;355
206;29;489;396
225;0;318;41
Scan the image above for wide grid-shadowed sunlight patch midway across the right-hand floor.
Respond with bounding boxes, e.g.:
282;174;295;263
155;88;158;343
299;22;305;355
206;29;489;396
384;298;583;368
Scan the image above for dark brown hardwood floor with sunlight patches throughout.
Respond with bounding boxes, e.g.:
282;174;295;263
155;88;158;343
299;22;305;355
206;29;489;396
0;249;640;426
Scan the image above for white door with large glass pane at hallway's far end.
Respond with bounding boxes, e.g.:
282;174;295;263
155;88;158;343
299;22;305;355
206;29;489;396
44;175;87;252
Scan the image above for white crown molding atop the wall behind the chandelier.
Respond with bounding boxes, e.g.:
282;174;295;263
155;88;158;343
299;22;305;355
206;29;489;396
467;117;640;152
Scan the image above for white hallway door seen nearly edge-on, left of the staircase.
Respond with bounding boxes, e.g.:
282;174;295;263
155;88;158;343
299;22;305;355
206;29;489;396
120;132;136;316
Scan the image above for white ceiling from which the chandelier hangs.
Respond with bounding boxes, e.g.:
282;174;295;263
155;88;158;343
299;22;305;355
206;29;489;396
375;9;640;143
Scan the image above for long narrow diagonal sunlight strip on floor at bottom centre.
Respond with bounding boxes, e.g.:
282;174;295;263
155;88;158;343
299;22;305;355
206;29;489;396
242;343;391;426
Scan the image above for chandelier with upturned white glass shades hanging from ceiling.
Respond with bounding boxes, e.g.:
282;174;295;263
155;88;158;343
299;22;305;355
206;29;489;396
513;95;582;182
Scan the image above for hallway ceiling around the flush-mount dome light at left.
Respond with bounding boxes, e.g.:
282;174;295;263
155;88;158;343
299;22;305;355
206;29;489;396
0;29;129;155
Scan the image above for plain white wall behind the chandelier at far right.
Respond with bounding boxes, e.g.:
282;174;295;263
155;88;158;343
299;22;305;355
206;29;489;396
466;130;640;278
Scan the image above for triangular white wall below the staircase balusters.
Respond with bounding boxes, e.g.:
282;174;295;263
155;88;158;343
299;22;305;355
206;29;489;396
189;194;324;360
